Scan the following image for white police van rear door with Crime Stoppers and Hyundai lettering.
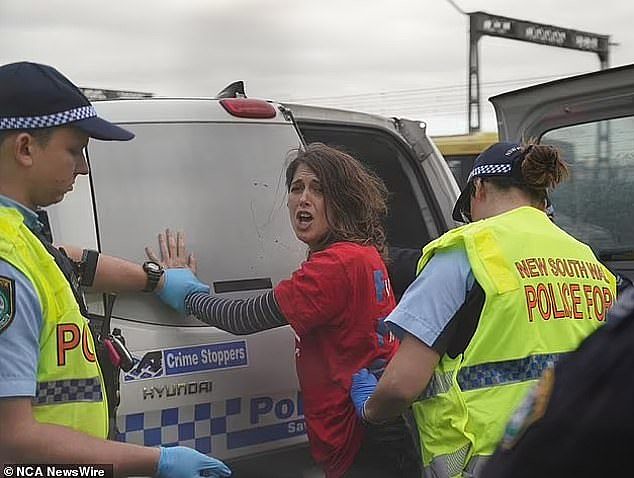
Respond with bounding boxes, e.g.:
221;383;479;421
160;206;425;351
47;99;306;464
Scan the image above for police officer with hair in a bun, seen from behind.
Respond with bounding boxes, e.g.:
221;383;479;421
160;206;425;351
351;143;616;477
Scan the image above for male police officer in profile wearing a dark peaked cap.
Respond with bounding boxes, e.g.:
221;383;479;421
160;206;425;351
0;62;230;478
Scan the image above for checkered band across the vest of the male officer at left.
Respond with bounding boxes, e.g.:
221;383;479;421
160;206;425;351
33;377;103;405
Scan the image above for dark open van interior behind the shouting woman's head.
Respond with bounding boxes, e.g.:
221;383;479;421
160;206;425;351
299;124;431;249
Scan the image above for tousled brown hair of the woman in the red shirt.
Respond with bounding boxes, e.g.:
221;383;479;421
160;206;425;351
286;143;388;259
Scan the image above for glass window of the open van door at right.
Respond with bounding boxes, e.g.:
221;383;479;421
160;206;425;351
541;117;634;259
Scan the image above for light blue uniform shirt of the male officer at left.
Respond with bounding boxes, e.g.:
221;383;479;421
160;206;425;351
0;195;43;397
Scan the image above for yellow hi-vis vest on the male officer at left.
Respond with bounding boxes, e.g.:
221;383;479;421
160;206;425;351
0;207;108;438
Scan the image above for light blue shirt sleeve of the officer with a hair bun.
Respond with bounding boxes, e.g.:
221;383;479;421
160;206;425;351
385;247;474;347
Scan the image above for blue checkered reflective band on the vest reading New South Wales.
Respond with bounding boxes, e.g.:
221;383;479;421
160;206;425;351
419;353;565;400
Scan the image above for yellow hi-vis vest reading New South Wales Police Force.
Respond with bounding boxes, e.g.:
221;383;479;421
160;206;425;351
413;207;616;478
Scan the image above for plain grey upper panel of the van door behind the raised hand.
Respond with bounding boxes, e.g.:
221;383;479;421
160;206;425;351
89;123;306;325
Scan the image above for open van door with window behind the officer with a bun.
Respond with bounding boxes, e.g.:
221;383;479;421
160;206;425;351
490;65;634;278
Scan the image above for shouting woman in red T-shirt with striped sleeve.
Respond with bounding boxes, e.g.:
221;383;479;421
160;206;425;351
148;143;420;478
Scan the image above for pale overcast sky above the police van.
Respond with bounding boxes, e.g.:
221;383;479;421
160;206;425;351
0;0;634;134
